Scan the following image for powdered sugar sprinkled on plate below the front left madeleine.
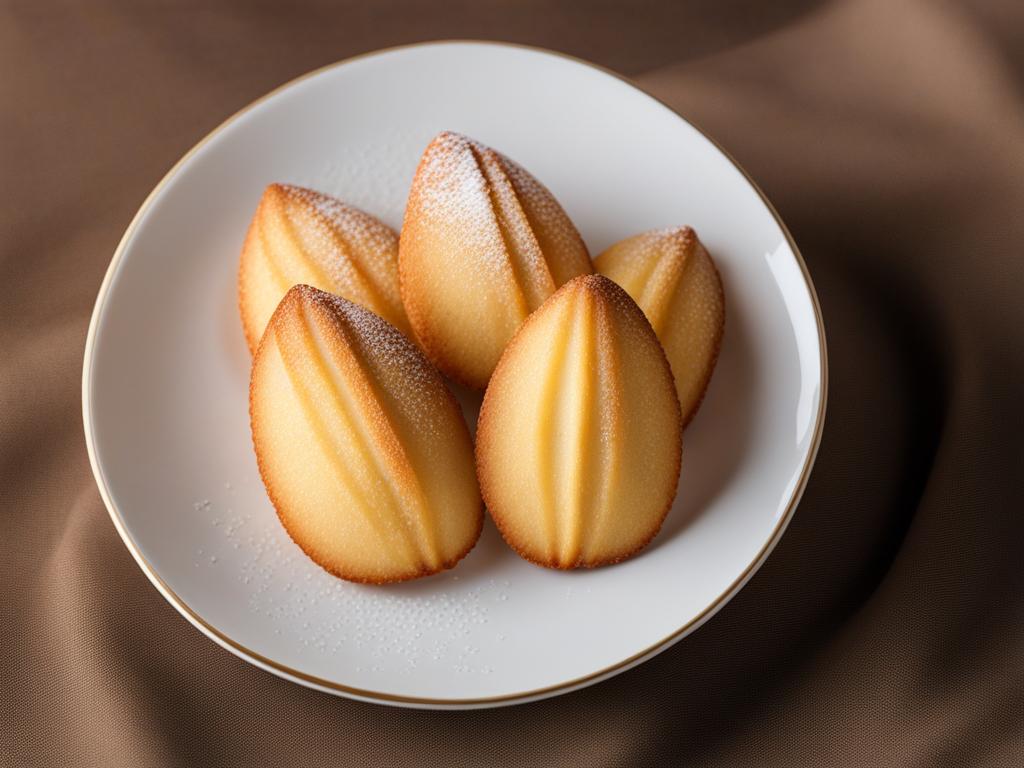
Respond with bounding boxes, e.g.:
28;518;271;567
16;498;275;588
194;499;514;679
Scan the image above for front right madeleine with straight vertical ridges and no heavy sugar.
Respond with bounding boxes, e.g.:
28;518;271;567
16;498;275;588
476;274;682;568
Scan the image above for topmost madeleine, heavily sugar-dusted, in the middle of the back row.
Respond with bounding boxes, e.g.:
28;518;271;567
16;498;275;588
398;132;593;389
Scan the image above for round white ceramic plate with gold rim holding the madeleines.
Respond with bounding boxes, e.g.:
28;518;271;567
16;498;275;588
83;43;826;708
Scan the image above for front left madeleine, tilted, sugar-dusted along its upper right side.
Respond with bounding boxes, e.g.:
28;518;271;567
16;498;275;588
249;286;482;584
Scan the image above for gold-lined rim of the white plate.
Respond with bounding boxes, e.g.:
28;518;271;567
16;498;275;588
82;38;828;710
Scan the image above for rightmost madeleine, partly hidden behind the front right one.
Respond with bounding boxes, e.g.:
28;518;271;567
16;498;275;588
594;226;725;427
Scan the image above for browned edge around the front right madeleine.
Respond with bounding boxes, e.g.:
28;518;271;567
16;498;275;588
474;272;683;570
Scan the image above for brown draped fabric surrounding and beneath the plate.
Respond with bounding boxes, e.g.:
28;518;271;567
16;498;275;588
0;0;1024;766
